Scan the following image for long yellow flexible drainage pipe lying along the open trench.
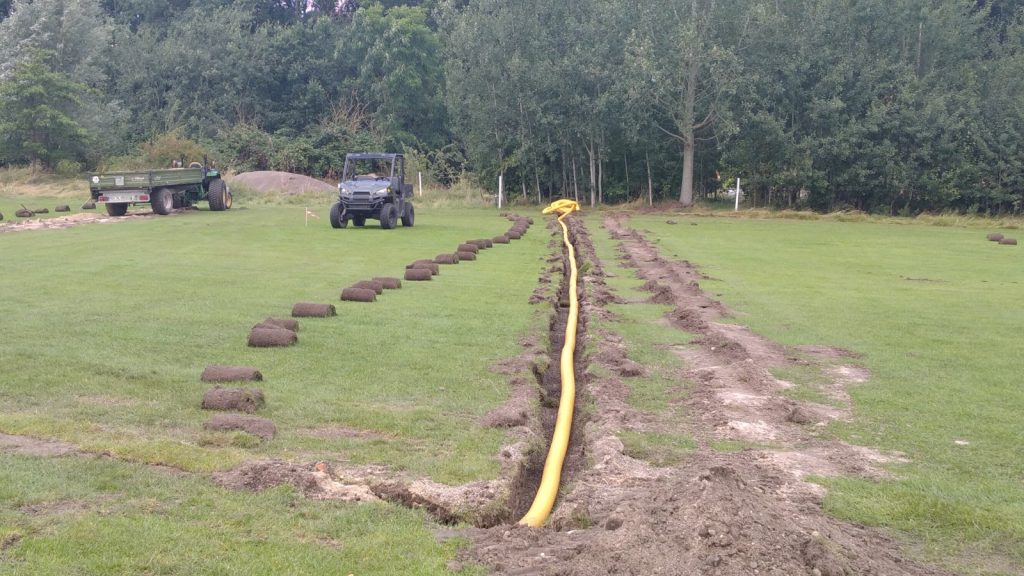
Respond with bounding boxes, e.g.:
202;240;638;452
519;200;580;528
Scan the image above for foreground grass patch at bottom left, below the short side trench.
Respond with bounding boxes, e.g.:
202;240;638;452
0;454;481;576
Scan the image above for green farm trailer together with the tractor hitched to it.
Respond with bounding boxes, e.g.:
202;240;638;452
89;162;231;216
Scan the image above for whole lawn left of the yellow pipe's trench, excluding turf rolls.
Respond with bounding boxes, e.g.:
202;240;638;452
0;190;548;574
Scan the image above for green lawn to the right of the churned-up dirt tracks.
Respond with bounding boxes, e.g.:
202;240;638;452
632;216;1024;574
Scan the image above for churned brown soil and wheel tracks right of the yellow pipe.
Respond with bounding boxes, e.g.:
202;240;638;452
456;216;945;576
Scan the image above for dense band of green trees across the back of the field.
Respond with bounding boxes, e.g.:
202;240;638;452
0;0;1024;214
